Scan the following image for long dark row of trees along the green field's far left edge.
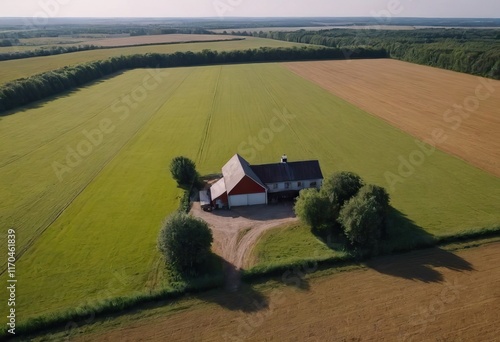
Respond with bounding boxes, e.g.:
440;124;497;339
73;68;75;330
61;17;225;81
0;47;386;112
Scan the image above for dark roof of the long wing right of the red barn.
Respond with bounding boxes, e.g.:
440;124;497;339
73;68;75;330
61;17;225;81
251;160;323;184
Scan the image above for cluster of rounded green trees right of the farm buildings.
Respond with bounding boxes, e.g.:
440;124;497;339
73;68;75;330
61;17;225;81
295;172;390;252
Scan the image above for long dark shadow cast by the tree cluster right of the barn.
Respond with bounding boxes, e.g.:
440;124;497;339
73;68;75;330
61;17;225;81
366;208;474;283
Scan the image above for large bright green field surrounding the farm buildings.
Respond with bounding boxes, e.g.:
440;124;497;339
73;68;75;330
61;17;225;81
0;64;500;319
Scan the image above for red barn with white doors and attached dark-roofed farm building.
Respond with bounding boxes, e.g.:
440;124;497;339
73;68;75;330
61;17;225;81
210;154;323;208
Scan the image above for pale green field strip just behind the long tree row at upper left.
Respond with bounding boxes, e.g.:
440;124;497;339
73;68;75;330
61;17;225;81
0;37;305;84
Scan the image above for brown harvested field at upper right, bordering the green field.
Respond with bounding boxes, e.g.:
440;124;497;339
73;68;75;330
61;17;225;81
286;59;500;177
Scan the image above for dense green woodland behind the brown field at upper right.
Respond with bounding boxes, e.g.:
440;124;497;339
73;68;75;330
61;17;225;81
242;29;500;79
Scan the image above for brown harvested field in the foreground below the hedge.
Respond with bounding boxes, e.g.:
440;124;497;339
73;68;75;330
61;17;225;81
43;243;500;341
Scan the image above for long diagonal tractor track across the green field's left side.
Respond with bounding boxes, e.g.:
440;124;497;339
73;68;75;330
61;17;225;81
0;71;192;276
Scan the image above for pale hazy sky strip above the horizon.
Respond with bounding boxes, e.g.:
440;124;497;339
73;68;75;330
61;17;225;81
0;0;500;18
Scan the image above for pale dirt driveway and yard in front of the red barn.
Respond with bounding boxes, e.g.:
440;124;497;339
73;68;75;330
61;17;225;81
191;202;297;287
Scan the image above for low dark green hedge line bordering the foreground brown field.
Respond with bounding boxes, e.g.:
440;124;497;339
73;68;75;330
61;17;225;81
4;226;500;338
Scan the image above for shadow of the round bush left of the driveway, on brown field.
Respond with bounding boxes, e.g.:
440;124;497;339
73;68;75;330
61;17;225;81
200;258;269;313
